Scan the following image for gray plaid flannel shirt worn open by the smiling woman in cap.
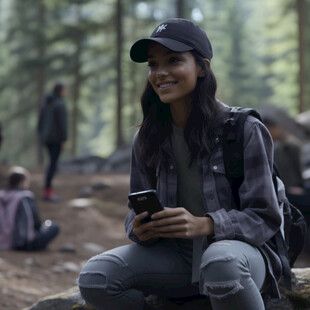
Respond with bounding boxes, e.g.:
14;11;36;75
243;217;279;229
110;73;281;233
125;110;282;297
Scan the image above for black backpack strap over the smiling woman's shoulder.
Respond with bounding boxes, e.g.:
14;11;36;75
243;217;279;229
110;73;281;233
223;107;261;207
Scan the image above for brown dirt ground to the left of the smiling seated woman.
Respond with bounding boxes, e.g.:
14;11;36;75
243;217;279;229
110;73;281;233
0;173;130;310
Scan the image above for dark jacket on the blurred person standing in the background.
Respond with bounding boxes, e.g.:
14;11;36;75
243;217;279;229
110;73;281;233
38;94;68;144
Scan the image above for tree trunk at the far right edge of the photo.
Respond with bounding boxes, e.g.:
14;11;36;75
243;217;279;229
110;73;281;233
296;0;307;113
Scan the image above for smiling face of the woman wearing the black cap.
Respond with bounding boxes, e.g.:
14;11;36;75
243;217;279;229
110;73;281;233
148;43;204;104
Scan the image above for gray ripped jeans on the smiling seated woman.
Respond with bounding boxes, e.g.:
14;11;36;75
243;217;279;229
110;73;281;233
78;240;266;310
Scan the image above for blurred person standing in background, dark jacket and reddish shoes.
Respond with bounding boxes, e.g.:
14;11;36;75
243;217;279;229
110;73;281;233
38;83;68;202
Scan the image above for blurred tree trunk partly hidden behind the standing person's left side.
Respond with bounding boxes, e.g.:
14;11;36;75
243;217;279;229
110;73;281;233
36;4;46;167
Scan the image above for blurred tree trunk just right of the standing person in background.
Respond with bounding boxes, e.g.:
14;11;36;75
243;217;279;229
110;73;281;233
71;6;83;156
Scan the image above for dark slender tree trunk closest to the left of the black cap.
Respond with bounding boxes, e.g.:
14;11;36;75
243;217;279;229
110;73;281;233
116;0;124;148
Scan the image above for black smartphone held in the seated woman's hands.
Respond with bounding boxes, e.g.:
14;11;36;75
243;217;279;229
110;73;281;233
128;189;164;222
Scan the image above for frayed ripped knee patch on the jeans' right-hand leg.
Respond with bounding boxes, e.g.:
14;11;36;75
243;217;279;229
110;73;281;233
200;255;244;299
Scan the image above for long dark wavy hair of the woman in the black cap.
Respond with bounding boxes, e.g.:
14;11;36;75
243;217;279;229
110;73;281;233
138;51;220;167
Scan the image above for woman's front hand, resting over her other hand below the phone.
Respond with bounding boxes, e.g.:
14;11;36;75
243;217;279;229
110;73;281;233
152;208;214;238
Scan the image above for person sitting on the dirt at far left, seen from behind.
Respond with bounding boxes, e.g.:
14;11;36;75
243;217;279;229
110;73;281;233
0;167;59;251
